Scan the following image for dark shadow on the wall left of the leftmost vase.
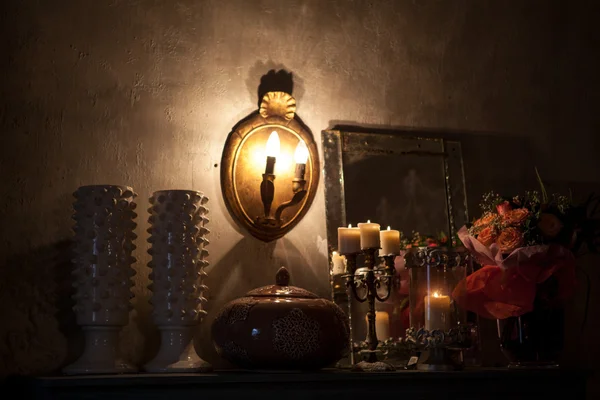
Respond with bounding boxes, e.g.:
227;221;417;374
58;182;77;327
0;240;73;377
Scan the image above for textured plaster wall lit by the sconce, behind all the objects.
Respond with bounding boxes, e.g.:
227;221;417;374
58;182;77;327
0;0;600;384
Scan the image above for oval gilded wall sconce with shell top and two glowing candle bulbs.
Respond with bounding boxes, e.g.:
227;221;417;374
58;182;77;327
221;92;320;242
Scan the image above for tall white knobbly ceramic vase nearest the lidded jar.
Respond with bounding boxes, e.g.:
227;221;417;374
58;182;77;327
144;190;211;372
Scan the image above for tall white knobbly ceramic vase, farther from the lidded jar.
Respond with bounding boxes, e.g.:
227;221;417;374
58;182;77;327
64;185;136;374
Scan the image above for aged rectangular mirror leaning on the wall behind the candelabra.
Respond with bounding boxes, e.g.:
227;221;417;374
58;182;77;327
322;130;469;363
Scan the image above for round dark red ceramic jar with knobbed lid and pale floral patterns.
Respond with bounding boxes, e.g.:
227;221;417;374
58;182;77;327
212;267;350;370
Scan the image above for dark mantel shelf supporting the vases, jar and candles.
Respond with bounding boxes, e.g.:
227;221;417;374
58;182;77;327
10;369;588;400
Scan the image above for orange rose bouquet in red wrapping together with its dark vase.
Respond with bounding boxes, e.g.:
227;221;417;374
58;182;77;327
453;180;599;366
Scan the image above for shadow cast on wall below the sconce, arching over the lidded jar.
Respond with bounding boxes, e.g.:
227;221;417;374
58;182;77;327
195;234;316;368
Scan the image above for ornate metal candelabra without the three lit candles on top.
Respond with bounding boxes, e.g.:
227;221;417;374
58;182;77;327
344;248;396;371
